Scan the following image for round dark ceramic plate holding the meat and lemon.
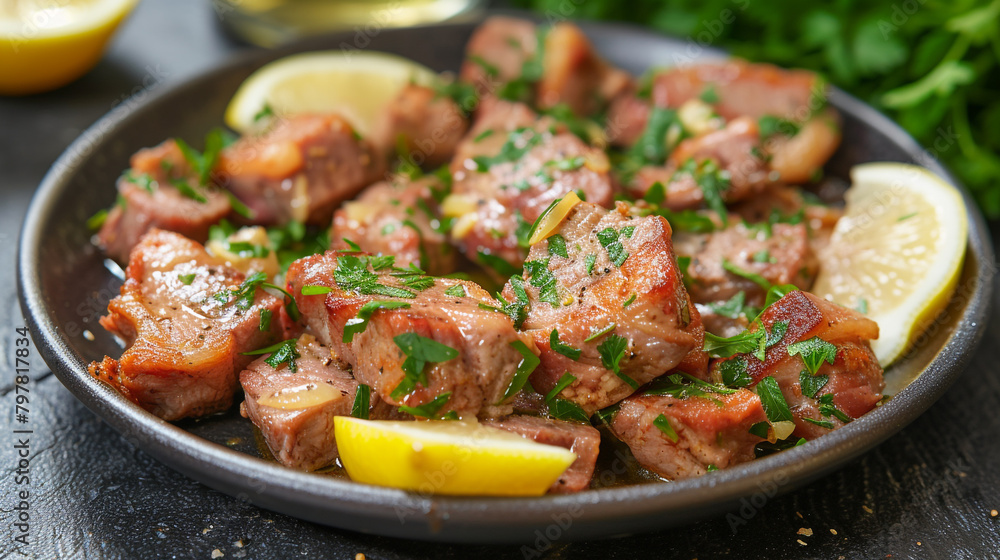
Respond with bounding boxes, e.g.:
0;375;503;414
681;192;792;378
18;16;993;542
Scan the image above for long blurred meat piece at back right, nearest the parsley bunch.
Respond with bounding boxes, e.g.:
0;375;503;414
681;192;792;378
652;60;826;122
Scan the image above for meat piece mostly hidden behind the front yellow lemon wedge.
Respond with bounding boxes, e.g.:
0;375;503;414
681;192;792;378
483;416;601;494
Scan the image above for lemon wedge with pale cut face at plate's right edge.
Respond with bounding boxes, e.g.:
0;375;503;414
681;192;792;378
812;163;969;367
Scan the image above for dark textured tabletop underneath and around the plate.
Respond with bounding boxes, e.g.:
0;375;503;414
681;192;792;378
0;0;1000;560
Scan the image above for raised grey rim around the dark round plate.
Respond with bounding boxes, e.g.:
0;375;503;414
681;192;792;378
17;16;995;543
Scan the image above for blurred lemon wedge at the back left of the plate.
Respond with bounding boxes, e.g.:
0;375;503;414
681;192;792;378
225;51;436;135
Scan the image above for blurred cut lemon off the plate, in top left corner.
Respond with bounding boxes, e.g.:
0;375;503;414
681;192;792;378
0;0;138;95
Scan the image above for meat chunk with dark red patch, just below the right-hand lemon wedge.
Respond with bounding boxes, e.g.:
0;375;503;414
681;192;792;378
711;291;885;439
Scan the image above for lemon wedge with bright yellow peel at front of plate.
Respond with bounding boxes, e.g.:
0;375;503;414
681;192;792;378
334;416;576;496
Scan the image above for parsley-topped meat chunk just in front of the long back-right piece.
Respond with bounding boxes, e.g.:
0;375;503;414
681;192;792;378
629;118;772;210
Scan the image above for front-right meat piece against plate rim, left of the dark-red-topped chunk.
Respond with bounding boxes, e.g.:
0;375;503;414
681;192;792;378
611;389;767;480
